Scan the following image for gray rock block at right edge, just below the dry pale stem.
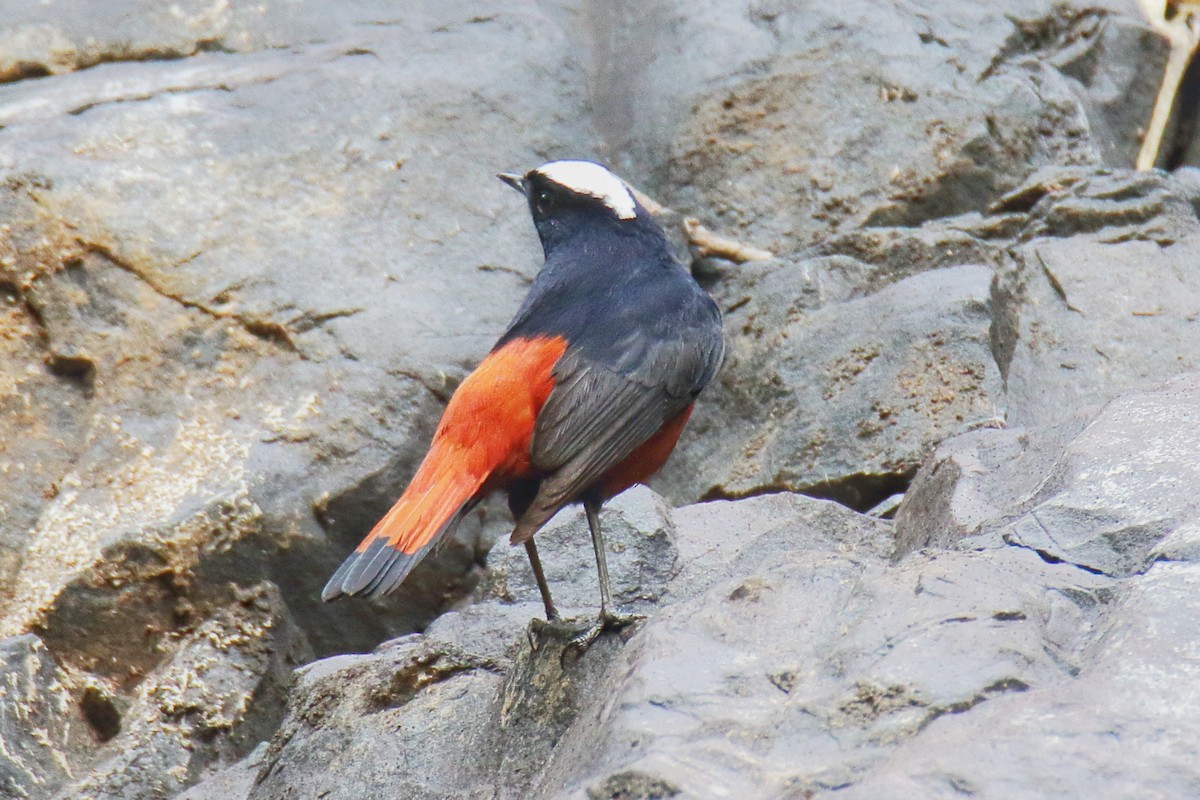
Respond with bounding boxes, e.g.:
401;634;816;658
992;172;1200;425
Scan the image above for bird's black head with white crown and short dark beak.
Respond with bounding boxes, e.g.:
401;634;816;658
499;161;654;255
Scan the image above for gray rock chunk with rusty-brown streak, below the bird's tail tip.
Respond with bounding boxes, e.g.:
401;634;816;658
250;618;502;799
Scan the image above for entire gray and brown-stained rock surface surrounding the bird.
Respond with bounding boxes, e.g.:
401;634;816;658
0;0;1200;799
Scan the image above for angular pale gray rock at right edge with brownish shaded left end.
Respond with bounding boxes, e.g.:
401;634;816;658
896;374;1200;576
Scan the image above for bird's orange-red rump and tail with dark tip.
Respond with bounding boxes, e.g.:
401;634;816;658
320;337;566;600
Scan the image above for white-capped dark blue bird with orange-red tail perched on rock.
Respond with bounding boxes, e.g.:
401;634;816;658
322;161;725;649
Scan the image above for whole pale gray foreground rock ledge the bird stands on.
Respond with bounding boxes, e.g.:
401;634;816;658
199;375;1200;800
